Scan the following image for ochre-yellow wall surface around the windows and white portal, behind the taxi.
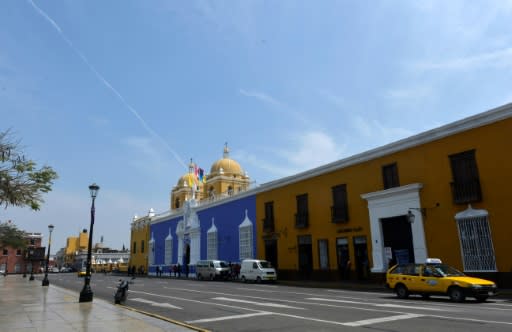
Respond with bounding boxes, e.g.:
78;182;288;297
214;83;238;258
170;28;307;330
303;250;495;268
256;119;512;272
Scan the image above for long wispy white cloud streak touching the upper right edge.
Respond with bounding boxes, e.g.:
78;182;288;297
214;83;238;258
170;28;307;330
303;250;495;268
415;47;512;71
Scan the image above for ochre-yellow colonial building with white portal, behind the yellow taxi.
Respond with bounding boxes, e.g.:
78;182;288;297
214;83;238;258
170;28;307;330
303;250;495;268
256;104;512;285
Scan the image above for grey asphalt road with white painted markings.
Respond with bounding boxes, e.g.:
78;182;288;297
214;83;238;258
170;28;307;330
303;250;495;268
50;274;512;332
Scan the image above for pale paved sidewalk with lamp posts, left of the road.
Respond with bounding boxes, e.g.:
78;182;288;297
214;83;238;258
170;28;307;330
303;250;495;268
0;275;202;332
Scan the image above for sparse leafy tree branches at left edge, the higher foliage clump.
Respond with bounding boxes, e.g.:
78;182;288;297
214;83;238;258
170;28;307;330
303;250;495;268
0;130;58;211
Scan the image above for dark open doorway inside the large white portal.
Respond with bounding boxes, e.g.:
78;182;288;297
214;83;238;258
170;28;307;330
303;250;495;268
381;216;415;267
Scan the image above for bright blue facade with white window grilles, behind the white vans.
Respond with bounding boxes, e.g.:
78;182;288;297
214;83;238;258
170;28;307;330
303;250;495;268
148;193;257;277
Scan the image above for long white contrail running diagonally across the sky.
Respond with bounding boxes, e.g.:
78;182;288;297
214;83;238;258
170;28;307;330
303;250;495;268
27;0;187;169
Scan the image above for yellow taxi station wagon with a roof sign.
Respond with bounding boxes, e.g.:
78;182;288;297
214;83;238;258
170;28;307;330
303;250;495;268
386;258;497;302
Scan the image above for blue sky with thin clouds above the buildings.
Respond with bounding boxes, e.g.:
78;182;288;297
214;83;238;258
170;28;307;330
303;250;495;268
0;0;512;254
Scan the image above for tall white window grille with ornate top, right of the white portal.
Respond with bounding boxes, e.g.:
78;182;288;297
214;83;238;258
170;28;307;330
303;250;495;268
456;215;496;272
